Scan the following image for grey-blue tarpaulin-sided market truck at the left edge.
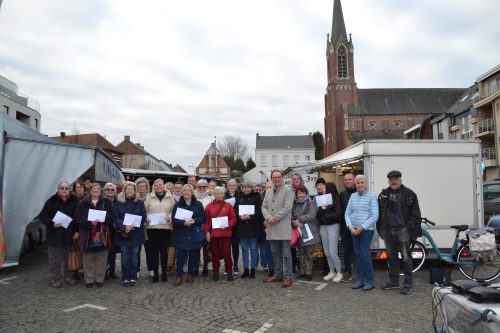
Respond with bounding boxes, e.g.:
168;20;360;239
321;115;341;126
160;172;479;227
0;114;123;267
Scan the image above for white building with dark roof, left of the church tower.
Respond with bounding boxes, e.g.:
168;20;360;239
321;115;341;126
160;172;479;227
243;133;315;184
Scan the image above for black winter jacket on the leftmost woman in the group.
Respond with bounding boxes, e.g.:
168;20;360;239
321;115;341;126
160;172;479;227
39;193;78;246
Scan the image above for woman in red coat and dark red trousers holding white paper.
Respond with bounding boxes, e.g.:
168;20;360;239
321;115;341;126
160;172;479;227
204;186;236;281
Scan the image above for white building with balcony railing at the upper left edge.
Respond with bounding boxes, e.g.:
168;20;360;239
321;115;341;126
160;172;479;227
0;75;41;132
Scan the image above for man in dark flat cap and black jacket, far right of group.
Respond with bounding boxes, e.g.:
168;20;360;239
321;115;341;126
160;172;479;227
377;170;422;295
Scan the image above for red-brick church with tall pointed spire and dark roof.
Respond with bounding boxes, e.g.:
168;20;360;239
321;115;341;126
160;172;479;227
324;0;466;157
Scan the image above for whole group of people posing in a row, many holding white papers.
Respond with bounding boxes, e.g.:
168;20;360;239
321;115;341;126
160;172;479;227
39;170;421;294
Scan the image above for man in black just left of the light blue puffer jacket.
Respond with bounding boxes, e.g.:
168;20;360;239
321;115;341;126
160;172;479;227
340;173;356;282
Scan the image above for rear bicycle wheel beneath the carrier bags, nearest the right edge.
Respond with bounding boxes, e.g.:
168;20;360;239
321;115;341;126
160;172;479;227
457;245;500;282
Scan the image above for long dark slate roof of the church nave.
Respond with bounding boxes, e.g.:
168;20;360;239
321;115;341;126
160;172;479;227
348;88;466;115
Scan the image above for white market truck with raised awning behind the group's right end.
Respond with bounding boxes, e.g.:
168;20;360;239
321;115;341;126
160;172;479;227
292;140;484;253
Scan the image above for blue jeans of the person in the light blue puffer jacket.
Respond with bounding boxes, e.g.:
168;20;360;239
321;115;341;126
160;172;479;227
352;230;374;284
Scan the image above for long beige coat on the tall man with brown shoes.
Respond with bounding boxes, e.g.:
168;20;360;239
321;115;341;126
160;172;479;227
262;185;294;240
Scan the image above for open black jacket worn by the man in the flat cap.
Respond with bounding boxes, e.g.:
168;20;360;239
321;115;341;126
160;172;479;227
377;185;422;239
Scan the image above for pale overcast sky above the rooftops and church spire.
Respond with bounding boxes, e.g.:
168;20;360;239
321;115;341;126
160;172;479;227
0;0;500;171
